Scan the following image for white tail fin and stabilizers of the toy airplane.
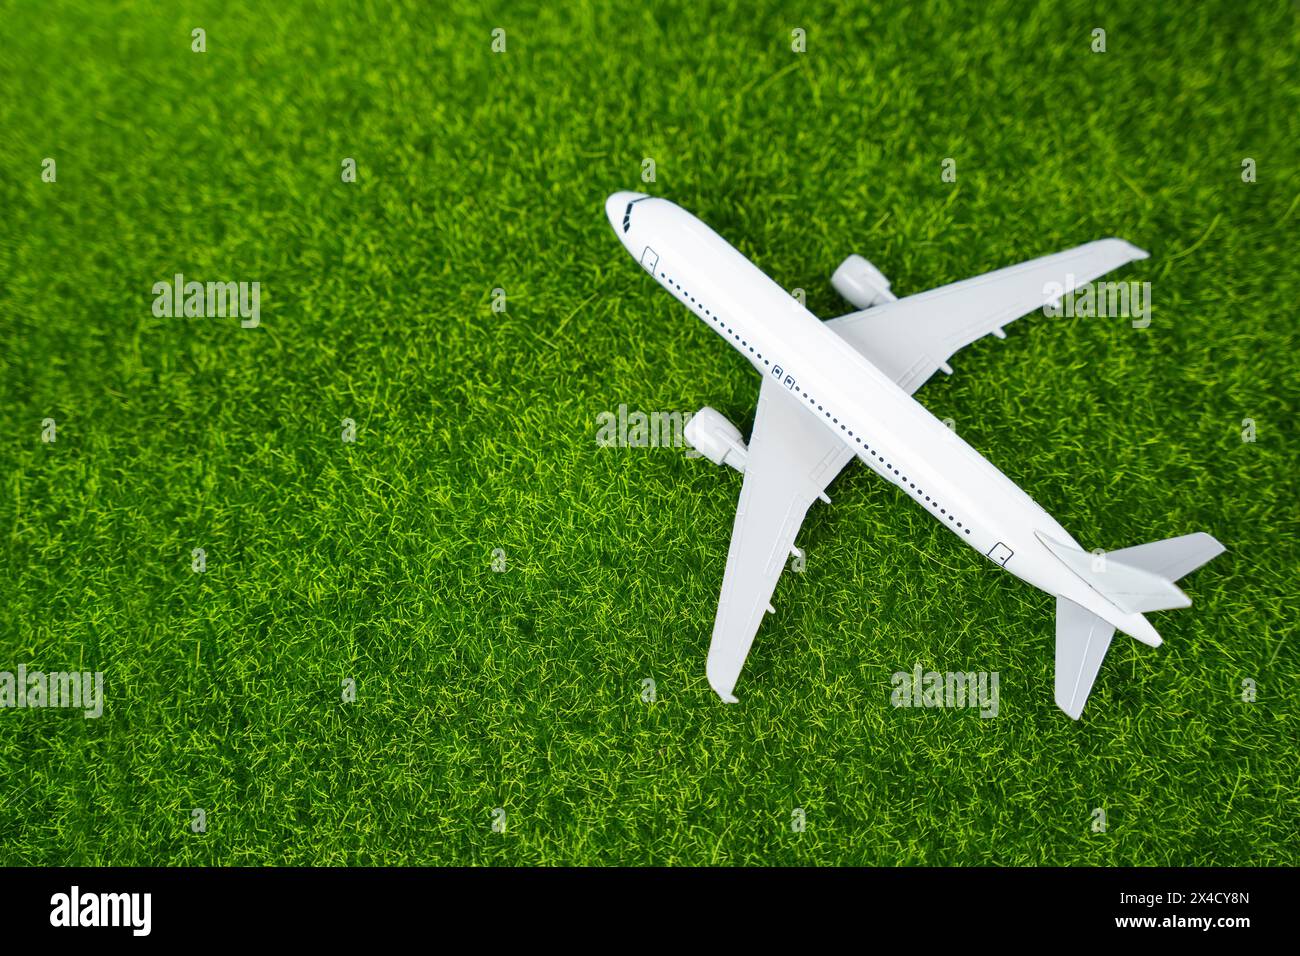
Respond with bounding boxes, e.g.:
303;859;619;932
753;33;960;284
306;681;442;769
1039;532;1225;721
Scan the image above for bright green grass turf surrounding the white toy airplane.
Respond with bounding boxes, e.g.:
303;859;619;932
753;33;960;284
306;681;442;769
0;3;1300;865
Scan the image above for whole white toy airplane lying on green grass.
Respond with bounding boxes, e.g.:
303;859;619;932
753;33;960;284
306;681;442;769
605;193;1223;719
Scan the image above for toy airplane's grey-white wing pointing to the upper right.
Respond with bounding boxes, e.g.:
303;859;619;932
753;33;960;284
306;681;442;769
827;239;1147;394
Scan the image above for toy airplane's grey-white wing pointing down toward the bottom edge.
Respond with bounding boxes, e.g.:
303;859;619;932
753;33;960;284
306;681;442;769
706;377;853;704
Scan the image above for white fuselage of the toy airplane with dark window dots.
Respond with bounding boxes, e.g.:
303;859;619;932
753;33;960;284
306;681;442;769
606;193;1160;645
